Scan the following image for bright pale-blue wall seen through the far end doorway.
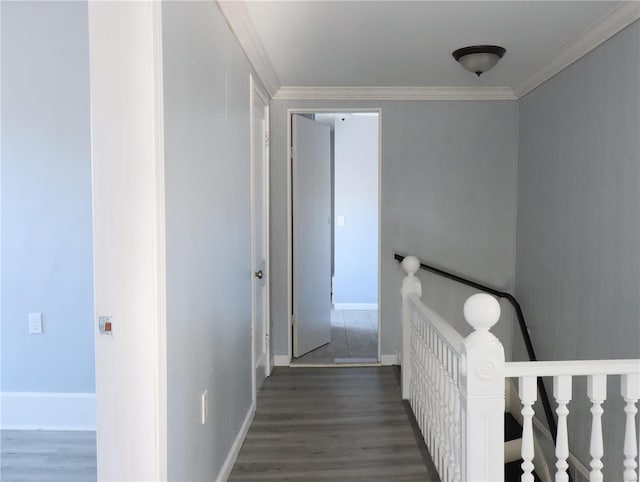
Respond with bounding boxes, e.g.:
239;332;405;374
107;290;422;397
333;114;378;303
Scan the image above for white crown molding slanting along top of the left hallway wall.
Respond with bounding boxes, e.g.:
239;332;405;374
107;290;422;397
218;0;280;97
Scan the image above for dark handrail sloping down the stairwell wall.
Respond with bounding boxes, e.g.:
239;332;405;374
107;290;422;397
394;253;558;444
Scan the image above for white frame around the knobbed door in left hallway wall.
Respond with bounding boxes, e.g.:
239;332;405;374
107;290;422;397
249;74;273;402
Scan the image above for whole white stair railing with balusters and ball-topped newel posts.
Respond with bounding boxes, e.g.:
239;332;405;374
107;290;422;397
401;256;640;482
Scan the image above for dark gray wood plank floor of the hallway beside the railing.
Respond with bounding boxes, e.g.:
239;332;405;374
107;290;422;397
229;367;439;482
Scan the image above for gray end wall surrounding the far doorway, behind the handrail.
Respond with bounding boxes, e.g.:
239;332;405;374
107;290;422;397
270;100;518;355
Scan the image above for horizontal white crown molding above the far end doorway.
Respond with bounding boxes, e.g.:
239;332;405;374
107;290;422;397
273;86;517;100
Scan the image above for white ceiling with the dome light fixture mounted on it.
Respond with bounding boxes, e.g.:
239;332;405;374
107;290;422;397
228;0;638;97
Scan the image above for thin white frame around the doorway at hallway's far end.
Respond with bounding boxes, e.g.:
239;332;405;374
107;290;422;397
287;107;382;367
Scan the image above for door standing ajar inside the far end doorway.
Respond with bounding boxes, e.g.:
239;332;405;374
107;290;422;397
292;114;331;358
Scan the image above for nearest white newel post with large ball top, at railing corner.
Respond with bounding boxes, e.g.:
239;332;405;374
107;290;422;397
460;294;504;482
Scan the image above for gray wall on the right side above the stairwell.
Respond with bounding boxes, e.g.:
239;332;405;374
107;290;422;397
516;22;640;480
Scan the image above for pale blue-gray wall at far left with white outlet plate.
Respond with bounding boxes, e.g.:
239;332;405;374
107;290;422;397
0;2;95;393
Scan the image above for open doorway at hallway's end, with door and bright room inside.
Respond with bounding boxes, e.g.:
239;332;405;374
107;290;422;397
289;110;380;366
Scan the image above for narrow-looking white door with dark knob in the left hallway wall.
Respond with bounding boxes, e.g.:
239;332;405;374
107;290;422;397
251;79;270;399
